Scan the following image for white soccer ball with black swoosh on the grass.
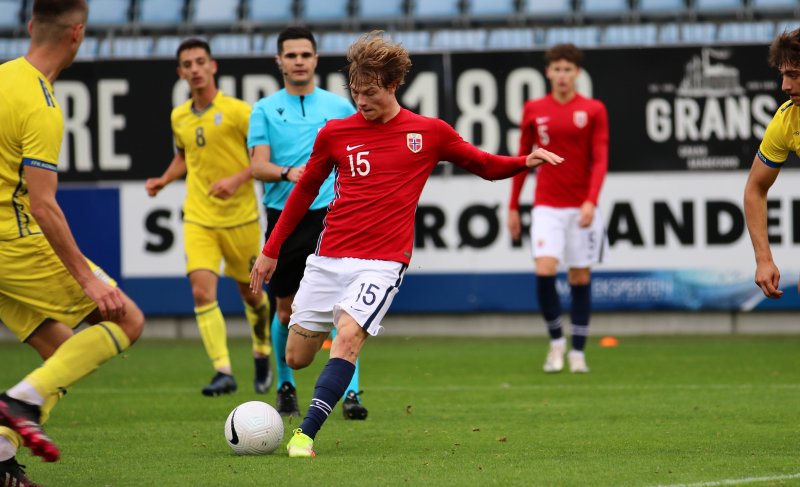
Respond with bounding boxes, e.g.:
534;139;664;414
225;401;283;455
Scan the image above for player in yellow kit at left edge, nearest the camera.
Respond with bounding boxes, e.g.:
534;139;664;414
0;0;144;486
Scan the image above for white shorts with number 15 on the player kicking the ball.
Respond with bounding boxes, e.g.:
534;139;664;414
291;254;406;336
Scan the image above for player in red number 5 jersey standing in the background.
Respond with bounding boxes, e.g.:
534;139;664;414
508;44;608;373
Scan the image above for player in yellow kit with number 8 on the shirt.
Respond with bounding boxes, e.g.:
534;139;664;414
145;39;272;396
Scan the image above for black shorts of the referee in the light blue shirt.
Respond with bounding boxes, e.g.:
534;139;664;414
265;208;328;298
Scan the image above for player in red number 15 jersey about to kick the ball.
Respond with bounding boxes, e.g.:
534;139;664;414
251;32;562;457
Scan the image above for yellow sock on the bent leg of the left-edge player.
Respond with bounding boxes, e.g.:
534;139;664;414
25;321;131;400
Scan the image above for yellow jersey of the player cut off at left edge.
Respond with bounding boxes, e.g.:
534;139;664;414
0;57;63;240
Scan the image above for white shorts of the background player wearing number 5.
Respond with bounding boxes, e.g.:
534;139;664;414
531;206;608;268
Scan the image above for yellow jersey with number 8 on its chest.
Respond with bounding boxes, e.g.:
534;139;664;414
171;91;258;228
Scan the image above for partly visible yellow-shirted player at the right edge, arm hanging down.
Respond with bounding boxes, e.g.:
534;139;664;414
744;29;800;299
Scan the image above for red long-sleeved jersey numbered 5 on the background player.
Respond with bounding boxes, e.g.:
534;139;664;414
509;93;608;209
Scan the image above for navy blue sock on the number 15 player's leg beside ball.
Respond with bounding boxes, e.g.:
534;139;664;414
300;358;356;438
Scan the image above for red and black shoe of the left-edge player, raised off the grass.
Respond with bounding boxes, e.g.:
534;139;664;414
0;392;61;462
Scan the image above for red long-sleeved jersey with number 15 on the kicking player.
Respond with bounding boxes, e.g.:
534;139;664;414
262;109;527;264
